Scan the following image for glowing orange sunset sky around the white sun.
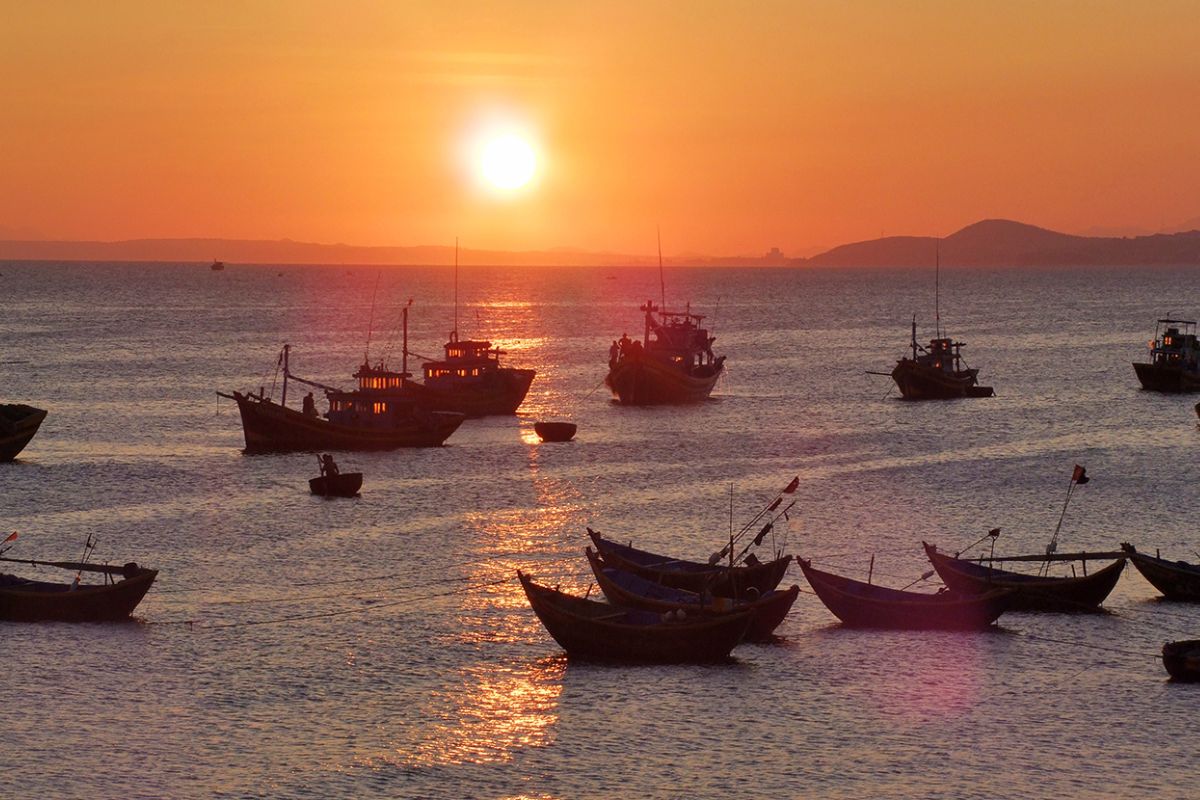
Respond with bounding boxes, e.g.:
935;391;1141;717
0;0;1200;254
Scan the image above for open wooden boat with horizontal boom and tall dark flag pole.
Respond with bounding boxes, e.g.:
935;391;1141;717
922;542;1126;612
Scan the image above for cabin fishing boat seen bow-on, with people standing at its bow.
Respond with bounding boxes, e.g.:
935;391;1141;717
605;300;725;405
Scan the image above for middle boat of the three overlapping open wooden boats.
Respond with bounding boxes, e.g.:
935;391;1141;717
584;547;800;642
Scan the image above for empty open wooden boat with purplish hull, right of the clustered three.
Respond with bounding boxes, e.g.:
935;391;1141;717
796;558;1012;631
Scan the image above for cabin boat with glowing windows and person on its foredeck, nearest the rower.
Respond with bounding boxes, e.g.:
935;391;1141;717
217;344;466;452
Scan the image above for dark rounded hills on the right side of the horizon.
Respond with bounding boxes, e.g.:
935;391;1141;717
792;219;1200;266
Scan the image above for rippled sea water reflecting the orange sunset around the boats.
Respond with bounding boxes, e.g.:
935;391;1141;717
0;263;1200;800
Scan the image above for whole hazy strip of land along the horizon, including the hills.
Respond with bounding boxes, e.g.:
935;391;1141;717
0;219;1200;266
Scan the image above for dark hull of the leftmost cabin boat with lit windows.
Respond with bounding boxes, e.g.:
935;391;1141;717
227;392;464;453
